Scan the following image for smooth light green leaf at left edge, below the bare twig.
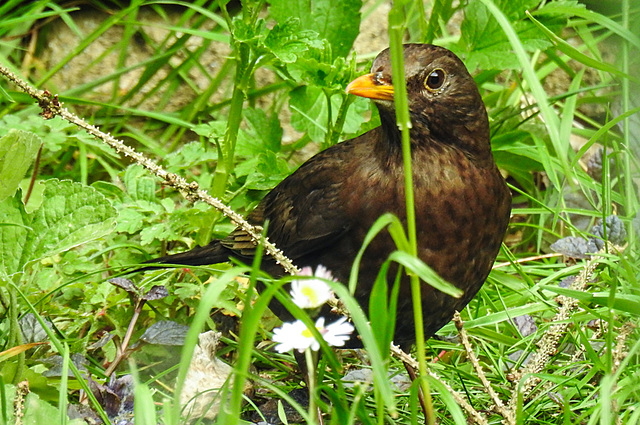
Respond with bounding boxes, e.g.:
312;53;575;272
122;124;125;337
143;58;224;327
0;130;42;200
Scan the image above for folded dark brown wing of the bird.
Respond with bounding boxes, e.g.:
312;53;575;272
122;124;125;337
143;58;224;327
222;147;351;260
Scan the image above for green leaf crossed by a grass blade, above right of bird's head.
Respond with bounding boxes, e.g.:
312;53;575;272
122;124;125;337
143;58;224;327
452;0;563;70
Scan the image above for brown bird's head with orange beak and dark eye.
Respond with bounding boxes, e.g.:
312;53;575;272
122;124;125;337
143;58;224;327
346;44;490;155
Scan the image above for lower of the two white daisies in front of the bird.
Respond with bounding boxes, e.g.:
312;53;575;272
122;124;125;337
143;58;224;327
272;317;354;353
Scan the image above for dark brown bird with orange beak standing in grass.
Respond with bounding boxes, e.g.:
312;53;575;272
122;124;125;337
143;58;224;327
144;44;511;348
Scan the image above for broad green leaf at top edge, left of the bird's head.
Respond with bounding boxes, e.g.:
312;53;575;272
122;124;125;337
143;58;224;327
269;0;362;58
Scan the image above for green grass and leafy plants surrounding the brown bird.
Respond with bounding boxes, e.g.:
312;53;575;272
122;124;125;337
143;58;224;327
0;0;640;424
